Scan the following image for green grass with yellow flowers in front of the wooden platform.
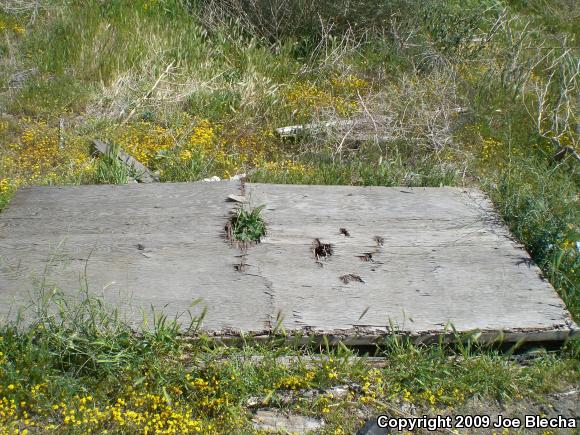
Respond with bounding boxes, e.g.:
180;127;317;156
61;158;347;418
0;291;580;433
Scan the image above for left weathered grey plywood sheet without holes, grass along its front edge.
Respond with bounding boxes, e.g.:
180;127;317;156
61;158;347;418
0;182;268;330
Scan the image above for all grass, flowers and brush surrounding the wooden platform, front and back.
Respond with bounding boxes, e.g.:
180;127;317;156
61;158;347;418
0;0;580;433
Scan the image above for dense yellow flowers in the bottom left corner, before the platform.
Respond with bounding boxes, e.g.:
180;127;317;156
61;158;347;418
0;360;260;434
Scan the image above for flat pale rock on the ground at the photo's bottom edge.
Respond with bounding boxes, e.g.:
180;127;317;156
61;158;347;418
252;409;324;434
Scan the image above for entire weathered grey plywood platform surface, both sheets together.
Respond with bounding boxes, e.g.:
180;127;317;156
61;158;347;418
0;182;575;344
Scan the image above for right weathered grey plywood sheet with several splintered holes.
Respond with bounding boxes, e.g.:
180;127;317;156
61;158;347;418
241;184;571;335
